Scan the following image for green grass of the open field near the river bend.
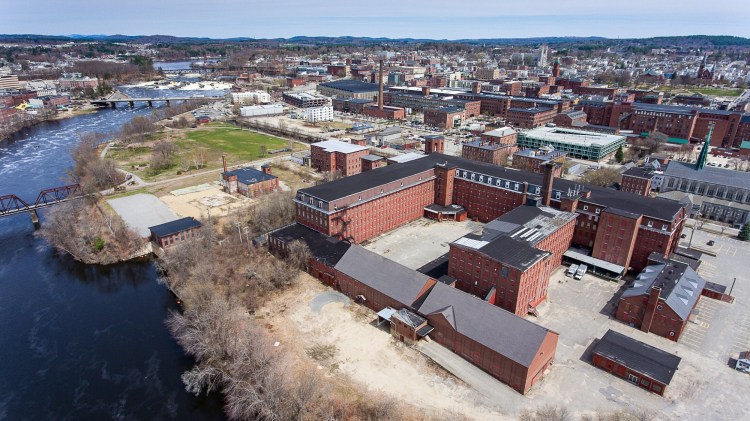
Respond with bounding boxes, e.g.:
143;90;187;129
187;124;287;162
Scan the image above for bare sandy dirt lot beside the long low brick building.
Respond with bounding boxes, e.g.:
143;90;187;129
256;274;513;419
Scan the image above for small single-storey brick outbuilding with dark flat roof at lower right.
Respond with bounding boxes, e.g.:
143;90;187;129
592;330;681;396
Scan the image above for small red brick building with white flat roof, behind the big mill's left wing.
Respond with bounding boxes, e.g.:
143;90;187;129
310;140;370;177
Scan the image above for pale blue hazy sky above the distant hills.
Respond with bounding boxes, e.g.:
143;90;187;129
0;0;750;39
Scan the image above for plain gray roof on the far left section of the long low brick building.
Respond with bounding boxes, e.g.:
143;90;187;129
334;245;430;306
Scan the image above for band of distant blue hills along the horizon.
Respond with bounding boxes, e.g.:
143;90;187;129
0;34;750;48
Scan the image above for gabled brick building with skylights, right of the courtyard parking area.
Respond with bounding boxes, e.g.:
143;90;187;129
616;260;706;342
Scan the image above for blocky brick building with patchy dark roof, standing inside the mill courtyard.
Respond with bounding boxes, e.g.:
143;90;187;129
448;206;577;316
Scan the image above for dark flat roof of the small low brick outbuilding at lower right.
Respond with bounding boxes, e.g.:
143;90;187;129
594;330;682;384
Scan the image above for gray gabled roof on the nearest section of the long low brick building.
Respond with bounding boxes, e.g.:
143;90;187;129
417;283;556;367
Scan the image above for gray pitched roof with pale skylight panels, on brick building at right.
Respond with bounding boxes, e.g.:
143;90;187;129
622;261;706;320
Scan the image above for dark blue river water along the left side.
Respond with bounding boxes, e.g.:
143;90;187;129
0;89;224;420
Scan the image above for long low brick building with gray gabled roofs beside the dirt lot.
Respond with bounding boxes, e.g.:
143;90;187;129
269;224;559;394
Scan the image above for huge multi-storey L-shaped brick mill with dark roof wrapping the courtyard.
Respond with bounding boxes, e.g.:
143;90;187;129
295;153;686;270
